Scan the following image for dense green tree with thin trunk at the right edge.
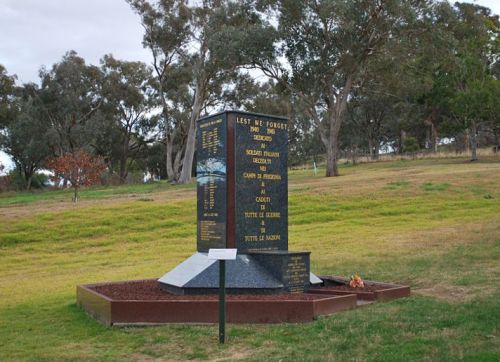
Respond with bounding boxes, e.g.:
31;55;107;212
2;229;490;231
421;3;500;160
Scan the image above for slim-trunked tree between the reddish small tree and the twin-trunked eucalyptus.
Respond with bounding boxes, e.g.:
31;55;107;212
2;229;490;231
96;55;156;183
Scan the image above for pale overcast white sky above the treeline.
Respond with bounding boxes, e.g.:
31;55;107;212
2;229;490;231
0;0;500;171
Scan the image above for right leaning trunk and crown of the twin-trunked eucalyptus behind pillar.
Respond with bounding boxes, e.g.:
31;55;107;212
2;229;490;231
179;0;274;183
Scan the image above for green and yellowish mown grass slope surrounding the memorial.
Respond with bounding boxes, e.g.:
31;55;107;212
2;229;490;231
0;157;500;361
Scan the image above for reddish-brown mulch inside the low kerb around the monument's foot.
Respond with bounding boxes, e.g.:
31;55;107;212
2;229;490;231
89;279;325;301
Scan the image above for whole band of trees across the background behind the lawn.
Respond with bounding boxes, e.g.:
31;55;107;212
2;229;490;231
0;0;500;178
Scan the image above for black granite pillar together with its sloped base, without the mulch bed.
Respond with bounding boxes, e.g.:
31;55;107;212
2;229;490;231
159;111;321;294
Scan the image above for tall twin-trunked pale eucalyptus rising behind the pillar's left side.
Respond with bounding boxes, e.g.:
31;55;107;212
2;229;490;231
128;0;273;183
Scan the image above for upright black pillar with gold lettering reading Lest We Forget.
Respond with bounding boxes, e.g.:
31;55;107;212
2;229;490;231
196;112;288;253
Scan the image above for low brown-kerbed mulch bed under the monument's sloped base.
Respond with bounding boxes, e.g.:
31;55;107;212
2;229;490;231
76;279;356;326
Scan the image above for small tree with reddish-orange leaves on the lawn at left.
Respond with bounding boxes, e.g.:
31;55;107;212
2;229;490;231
47;150;106;202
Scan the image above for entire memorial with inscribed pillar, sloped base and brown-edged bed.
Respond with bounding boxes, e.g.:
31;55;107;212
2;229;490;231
77;111;410;326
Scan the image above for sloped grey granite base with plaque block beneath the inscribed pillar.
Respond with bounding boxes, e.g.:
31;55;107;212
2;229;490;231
158;251;321;295
